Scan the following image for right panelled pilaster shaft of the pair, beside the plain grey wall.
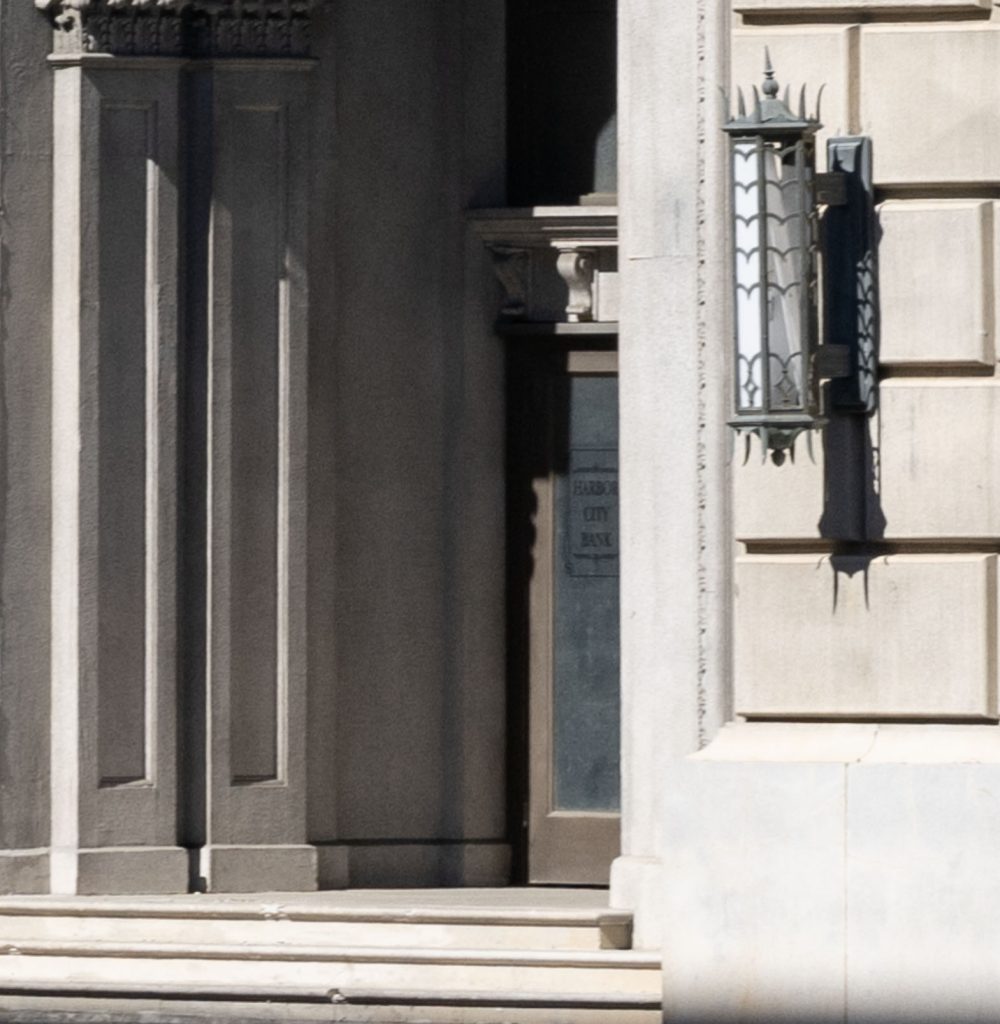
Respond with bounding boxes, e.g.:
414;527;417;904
192;59;316;891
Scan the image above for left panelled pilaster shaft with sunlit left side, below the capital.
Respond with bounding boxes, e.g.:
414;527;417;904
50;52;187;893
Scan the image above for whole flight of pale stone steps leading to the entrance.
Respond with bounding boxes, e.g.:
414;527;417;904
0;888;660;1024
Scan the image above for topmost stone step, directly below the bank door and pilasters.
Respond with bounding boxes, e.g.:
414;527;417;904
0;897;632;951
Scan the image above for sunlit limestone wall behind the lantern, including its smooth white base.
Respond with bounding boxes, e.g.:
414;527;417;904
660;0;1000;1024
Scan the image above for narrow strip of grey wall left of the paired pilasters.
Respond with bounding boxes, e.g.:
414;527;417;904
0;0;52;888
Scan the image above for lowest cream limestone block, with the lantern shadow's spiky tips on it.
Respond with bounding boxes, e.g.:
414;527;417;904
735;554;997;718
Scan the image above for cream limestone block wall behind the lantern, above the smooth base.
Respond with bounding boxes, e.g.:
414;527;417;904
732;0;1000;719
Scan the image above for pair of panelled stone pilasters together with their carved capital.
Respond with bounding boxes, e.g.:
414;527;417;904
38;0;315;893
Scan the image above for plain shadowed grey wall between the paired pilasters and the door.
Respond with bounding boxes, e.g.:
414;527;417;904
309;0;506;884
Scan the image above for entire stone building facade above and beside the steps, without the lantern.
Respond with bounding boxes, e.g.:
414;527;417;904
0;0;1000;1021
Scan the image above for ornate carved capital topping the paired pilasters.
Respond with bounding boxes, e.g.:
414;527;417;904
35;0;321;58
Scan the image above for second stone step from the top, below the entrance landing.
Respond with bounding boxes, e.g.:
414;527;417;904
0;940;660;997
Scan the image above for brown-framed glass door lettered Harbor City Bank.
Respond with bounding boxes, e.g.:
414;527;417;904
515;352;620;885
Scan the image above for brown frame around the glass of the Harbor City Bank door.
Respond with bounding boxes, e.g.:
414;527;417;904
508;335;621;885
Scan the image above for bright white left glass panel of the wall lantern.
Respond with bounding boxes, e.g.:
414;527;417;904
733;139;765;412
